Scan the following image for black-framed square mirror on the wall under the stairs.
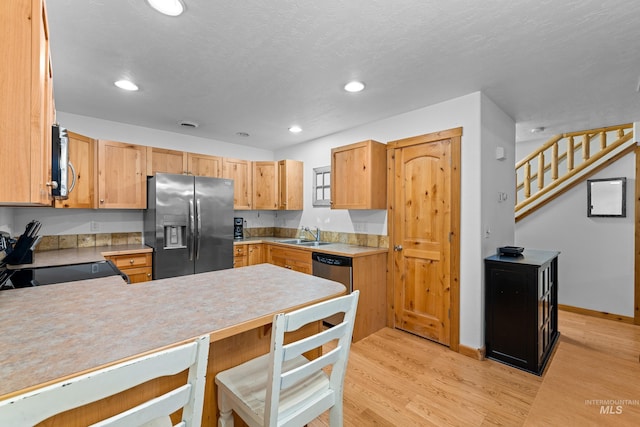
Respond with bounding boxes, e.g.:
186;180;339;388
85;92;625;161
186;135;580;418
587;178;627;217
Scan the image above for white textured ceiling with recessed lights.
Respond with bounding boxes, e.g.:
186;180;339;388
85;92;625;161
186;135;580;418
47;0;640;150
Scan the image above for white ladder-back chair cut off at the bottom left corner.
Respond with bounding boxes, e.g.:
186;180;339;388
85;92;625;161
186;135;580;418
0;335;209;427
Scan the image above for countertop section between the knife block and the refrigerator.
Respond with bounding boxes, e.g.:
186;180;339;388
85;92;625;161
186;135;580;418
9;244;153;269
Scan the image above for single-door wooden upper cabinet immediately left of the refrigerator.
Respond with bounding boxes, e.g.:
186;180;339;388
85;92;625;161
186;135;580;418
98;139;147;209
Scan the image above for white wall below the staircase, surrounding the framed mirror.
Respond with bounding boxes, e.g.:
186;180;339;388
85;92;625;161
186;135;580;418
516;154;636;317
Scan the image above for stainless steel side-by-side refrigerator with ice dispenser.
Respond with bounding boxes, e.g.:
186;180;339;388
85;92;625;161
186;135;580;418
144;173;233;279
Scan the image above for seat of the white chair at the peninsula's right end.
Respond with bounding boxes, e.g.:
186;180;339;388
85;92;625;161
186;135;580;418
216;354;334;425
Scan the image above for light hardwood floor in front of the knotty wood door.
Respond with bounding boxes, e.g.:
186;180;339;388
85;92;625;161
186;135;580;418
309;311;640;427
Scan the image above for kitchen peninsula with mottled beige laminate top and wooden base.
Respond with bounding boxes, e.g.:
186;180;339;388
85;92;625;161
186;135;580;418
0;264;345;425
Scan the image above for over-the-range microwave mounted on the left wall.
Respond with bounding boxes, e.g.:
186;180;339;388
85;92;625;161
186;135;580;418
51;124;76;200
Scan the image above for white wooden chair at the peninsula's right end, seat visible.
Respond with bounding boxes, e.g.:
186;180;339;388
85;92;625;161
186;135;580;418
216;291;359;427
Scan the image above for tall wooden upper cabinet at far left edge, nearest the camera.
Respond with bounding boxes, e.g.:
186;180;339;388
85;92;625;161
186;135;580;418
0;0;55;206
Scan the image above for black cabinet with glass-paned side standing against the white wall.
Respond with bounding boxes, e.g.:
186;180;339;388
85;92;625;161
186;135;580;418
485;250;559;375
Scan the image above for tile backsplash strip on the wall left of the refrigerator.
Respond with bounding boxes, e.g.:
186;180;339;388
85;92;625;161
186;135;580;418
36;232;142;251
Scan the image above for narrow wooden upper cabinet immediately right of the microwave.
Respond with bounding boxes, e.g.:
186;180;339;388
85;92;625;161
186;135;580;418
55;132;98;209
